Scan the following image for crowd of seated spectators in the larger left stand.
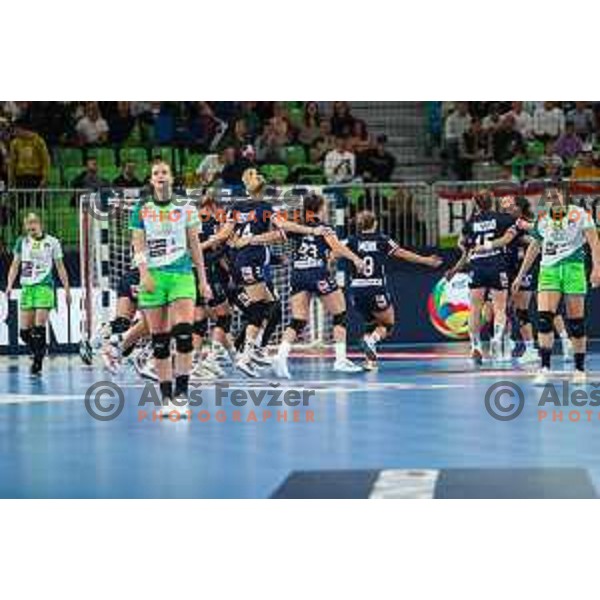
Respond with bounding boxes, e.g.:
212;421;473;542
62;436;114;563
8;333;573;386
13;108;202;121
0;101;395;188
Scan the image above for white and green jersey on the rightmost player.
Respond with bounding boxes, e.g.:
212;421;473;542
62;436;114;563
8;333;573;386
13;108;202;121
532;204;595;267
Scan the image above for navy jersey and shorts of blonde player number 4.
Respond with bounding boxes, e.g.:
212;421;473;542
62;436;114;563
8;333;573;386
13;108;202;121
228;199;274;285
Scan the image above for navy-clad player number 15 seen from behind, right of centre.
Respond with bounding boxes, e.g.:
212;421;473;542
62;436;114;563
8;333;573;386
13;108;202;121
448;194;517;364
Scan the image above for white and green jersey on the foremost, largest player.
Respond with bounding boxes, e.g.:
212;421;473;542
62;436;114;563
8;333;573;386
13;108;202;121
129;198;200;273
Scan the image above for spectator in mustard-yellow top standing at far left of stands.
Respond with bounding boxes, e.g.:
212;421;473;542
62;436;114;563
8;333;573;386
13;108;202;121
8;120;50;189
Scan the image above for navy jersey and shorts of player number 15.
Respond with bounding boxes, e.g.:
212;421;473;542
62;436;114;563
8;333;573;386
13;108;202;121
462;211;516;290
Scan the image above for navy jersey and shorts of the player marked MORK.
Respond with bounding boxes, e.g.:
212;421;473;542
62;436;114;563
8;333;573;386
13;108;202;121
347;232;399;319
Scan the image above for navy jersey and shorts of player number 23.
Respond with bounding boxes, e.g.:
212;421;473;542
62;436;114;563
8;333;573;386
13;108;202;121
287;218;338;296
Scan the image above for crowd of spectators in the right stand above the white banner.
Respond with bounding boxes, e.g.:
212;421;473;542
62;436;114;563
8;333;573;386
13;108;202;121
441;101;600;181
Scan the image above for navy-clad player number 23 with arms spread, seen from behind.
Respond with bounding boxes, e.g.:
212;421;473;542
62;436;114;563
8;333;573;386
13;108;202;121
273;194;365;378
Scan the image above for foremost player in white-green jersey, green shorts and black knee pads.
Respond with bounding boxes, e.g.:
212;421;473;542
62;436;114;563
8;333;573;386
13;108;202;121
130;161;212;417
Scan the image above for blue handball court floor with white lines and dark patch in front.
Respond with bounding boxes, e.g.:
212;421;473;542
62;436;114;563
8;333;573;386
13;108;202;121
0;343;600;498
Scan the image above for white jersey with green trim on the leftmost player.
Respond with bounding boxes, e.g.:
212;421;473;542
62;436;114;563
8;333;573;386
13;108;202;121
14;234;63;286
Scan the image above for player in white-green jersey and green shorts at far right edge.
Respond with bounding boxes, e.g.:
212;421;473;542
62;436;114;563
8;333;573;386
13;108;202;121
513;187;600;385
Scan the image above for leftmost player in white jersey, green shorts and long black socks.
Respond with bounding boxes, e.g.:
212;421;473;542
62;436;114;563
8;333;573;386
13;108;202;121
6;213;71;375
